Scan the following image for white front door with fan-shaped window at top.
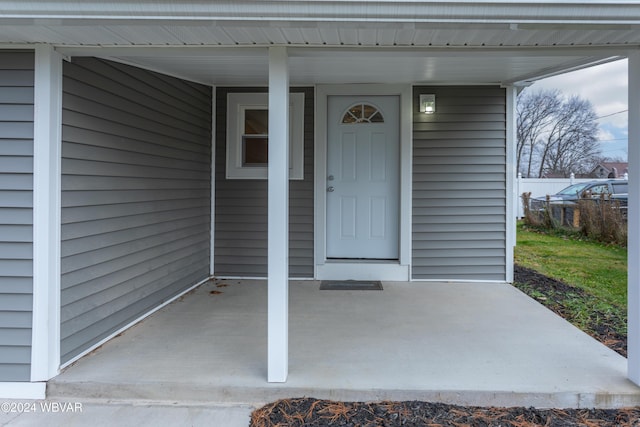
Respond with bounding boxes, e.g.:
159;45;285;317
326;96;400;260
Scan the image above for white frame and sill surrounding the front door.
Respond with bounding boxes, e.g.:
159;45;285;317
314;84;413;281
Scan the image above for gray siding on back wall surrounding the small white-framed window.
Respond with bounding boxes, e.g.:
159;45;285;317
215;88;314;278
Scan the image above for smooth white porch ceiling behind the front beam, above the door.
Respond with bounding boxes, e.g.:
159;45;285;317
52;47;618;86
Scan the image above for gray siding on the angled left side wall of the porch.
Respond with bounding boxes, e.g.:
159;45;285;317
61;58;211;363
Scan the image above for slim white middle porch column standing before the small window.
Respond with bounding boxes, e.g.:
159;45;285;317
268;47;289;382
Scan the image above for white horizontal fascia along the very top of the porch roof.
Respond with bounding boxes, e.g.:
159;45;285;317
6;0;640;25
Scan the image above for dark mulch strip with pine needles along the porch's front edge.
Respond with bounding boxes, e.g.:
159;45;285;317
251;398;640;427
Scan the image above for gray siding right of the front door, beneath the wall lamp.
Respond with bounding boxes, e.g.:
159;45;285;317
412;87;506;280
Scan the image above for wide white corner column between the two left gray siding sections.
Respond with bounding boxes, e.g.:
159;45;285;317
31;45;62;381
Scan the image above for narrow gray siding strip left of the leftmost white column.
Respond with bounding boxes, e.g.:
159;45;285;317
0;51;34;381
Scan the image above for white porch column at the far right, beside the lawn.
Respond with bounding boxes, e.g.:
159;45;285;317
627;50;640;385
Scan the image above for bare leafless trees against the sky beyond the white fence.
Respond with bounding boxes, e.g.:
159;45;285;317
517;90;601;177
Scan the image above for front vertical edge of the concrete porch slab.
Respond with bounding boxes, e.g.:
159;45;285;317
47;381;640;409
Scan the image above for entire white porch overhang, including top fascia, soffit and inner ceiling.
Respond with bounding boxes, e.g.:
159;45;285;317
0;0;640;85
